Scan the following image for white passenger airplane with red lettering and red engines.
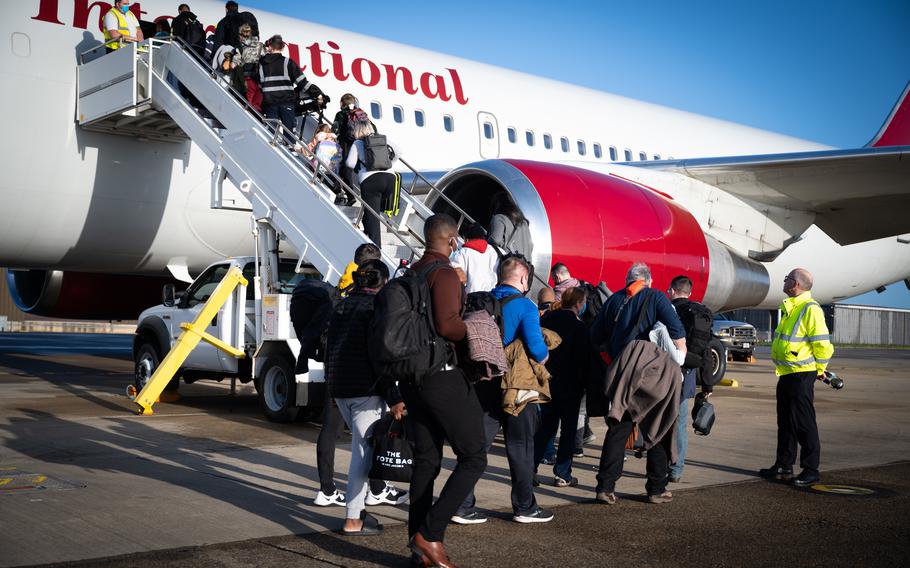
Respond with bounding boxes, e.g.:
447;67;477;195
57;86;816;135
0;0;910;319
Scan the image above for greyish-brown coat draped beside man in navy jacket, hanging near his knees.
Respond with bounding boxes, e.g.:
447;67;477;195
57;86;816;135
606;340;682;463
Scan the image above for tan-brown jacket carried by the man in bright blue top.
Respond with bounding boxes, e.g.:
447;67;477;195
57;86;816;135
502;329;562;416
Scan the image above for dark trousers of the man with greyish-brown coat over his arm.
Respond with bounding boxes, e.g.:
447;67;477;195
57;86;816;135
597;416;673;495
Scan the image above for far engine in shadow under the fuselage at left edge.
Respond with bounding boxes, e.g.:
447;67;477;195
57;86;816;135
7;270;179;320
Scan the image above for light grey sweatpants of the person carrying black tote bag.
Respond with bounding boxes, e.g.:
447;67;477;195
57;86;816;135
335;396;385;519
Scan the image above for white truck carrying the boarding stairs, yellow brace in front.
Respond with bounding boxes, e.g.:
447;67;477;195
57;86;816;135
133;256;325;422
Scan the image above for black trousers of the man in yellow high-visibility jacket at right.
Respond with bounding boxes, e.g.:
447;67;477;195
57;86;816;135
777;371;821;474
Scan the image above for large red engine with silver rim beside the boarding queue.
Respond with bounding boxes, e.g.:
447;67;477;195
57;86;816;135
433;160;768;309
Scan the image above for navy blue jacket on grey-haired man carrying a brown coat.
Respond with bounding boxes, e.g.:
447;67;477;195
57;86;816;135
591;288;686;359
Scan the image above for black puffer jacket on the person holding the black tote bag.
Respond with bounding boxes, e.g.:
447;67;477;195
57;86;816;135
325;289;401;405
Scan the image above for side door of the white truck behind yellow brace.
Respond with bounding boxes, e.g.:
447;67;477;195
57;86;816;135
171;264;231;371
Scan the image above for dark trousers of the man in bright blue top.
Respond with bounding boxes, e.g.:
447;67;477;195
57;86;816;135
458;379;536;515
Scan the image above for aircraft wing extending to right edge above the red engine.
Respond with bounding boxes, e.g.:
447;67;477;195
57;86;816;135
635;146;910;245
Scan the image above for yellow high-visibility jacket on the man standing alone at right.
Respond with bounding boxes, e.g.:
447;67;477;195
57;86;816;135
771;292;834;376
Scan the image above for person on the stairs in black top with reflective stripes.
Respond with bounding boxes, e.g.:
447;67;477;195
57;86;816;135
259;35;310;143
